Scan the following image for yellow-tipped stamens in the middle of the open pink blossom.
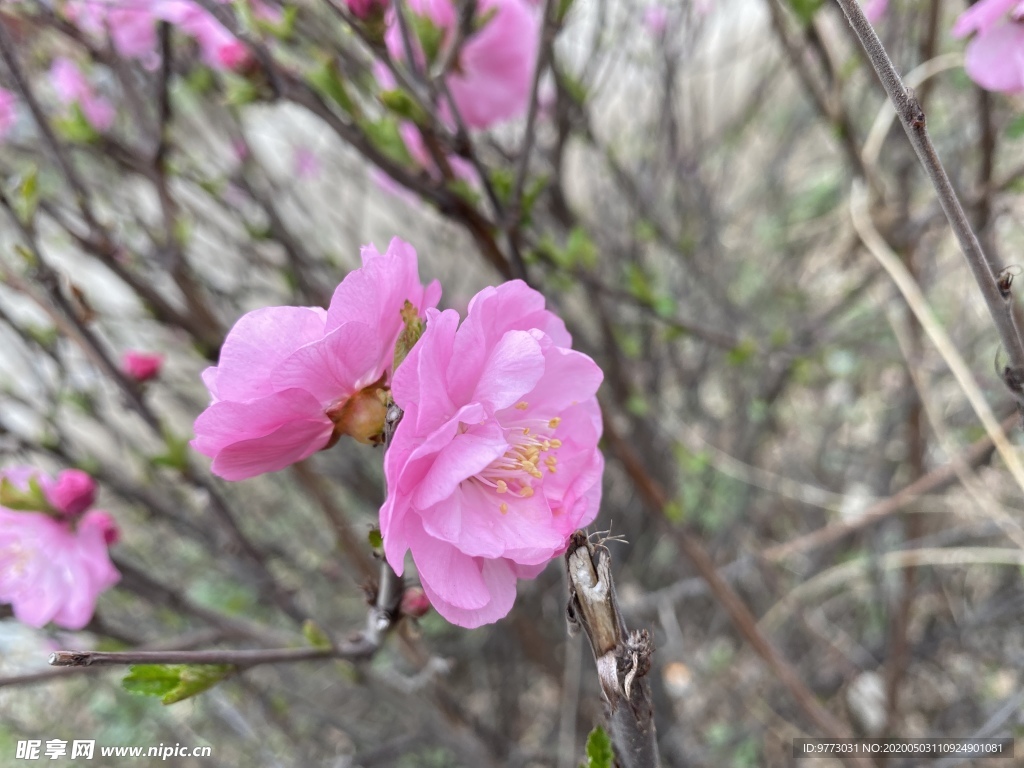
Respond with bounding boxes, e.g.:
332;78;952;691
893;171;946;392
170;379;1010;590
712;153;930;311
476;402;562;515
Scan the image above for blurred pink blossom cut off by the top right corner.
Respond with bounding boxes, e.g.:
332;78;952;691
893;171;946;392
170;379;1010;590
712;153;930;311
952;0;1024;93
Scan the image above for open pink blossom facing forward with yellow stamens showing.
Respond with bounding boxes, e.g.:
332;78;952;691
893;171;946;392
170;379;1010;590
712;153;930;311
381;281;604;627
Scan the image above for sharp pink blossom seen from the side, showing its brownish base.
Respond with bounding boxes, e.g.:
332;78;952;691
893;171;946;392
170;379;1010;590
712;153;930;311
191;238;440;480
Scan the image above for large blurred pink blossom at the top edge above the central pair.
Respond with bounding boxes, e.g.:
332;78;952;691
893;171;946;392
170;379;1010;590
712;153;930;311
385;0;541;128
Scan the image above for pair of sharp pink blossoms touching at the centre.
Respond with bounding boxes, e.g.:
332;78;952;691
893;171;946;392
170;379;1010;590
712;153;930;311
193;239;604;627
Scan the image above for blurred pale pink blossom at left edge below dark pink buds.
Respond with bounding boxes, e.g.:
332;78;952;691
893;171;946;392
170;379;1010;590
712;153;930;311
0;467;121;630
